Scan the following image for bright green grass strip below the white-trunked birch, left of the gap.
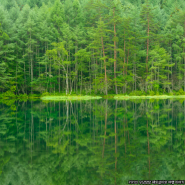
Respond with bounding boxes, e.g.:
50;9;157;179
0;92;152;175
41;96;102;101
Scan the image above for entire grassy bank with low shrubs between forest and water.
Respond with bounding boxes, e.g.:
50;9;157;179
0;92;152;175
0;88;185;101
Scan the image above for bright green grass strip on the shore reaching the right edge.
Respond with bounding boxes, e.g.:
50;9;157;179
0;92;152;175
114;95;185;100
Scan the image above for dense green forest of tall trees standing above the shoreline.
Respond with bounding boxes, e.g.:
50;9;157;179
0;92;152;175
0;0;185;96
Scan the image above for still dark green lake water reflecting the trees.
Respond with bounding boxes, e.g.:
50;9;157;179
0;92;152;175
0;99;185;185
